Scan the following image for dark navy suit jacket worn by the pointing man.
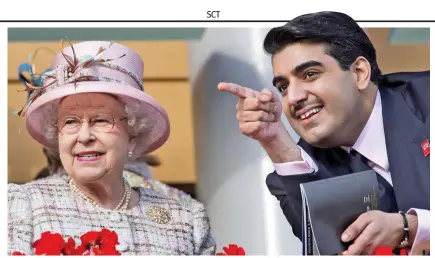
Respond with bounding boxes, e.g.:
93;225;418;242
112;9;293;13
266;71;430;240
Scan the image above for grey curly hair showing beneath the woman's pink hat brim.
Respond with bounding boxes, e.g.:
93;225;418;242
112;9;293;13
41;99;150;160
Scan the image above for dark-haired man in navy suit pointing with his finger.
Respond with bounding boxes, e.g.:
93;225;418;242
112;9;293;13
218;12;430;254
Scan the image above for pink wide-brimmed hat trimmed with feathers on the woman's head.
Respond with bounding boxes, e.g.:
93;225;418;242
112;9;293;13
19;41;170;153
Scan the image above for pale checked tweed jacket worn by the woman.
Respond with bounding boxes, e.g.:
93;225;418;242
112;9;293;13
8;177;216;255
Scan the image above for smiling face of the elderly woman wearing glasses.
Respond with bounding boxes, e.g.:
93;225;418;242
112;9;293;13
58;93;134;182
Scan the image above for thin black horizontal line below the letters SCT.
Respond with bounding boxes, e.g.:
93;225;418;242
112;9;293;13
0;19;435;23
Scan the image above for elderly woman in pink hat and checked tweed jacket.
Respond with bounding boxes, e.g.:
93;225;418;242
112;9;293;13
8;41;216;255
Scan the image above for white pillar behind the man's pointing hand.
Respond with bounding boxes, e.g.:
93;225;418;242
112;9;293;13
189;28;301;255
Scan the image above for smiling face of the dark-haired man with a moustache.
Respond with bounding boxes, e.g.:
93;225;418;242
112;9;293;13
273;42;374;148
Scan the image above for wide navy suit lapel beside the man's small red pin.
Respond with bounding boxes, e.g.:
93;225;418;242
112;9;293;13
379;87;430;211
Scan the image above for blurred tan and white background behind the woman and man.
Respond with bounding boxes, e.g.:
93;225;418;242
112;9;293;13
8;28;429;255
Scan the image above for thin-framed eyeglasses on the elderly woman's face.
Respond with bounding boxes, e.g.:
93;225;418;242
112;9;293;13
56;114;127;134
